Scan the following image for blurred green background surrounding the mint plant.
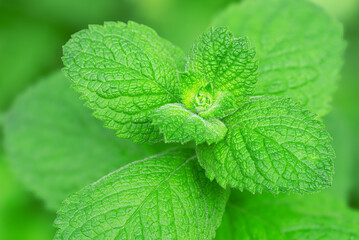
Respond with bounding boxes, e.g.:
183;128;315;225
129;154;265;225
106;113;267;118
0;0;359;240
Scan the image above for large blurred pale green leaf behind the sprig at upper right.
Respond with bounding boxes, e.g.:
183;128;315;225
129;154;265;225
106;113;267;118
213;0;345;116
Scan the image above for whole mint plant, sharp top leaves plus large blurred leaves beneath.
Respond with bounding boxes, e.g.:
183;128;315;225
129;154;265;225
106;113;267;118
5;0;359;239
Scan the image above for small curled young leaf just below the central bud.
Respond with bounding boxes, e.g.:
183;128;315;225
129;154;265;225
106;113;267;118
152;103;227;144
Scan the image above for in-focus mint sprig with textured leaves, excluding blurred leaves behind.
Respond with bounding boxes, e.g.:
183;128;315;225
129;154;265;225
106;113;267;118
56;15;334;239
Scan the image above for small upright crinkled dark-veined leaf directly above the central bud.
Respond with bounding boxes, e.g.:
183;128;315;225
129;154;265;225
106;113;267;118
188;27;257;95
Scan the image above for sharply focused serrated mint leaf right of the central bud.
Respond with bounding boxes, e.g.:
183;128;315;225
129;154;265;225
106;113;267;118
197;97;335;193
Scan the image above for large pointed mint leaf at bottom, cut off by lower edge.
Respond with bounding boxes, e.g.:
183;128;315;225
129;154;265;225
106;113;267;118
55;150;229;240
